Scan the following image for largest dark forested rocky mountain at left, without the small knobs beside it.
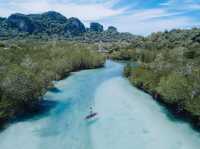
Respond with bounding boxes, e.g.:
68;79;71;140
0;11;86;38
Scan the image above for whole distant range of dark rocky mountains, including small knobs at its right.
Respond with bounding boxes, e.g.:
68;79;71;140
0;11;137;42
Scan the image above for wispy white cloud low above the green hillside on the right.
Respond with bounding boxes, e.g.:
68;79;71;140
102;9;199;35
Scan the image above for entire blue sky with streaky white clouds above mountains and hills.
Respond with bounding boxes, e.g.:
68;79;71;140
0;0;200;35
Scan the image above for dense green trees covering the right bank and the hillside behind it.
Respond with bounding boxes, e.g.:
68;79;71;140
109;28;200;126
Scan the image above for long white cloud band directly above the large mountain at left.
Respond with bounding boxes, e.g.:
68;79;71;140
0;0;125;21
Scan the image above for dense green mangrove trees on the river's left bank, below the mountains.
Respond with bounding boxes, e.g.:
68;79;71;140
0;40;104;123
